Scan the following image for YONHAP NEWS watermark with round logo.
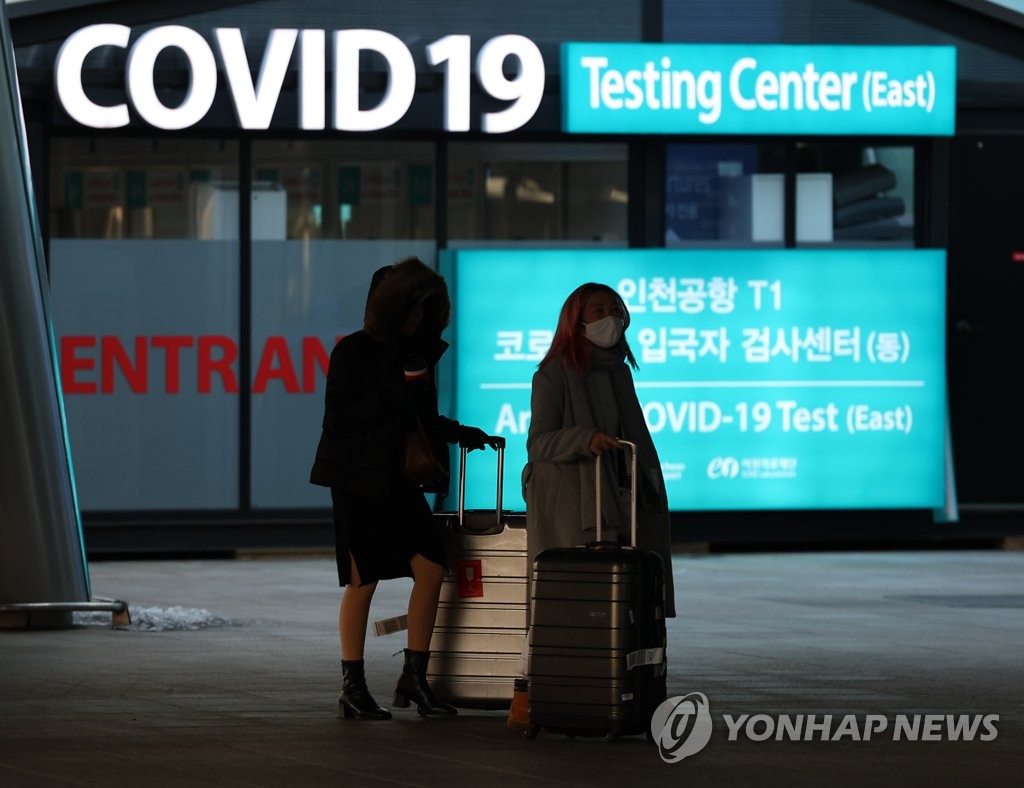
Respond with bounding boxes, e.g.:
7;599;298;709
650;692;999;763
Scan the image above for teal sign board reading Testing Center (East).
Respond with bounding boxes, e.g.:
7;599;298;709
561;42;956;136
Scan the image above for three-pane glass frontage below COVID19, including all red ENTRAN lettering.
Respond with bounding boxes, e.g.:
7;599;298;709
50;138;629;512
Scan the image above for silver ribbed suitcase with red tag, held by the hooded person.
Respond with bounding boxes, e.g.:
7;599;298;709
427;438;529;709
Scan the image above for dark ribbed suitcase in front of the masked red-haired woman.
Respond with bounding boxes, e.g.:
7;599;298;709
526;441;667;741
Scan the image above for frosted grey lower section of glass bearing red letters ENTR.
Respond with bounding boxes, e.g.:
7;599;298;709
50;238;239;511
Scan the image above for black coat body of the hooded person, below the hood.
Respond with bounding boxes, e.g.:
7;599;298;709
309;331;459;498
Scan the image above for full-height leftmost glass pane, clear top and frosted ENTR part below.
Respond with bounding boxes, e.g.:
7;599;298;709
49;139;240;511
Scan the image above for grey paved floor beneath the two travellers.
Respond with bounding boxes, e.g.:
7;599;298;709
0;551;1024;788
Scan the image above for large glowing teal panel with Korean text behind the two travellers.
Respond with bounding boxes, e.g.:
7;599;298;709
441;250;945;511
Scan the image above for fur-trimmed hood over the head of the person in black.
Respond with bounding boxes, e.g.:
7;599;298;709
362;257;452;338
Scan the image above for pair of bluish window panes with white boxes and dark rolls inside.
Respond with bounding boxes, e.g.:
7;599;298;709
665;141;914;248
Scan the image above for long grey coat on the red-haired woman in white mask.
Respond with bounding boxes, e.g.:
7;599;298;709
522;352;676;616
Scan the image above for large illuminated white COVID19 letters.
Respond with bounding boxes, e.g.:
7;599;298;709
54;25;545;134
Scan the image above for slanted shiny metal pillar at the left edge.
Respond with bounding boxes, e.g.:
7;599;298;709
0;3;92;627
